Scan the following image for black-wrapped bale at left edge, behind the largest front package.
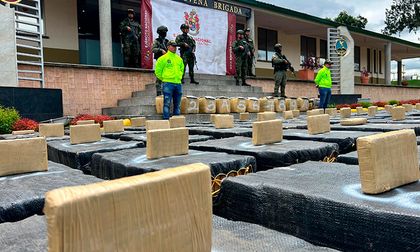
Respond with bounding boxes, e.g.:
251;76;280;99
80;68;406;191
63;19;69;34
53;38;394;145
0;161;101;222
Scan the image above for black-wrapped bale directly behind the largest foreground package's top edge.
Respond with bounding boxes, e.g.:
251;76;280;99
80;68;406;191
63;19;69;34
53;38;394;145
91;148;257;179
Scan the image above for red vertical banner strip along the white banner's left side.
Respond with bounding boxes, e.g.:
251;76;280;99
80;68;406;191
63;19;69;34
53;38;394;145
140;0;153;69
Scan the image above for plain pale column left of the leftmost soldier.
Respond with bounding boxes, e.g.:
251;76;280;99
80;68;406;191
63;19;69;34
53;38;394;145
98;0;113;66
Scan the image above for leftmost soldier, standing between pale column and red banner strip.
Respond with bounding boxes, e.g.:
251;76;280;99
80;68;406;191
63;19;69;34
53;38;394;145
120;9;141;67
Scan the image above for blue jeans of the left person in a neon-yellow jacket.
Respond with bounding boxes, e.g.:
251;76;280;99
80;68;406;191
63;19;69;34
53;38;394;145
162;82;182;120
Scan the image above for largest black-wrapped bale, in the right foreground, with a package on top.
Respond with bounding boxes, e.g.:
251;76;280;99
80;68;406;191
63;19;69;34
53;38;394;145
214;162;420;251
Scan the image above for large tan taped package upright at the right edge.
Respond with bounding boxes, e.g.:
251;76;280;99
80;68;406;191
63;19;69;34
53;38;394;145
357;130;420;194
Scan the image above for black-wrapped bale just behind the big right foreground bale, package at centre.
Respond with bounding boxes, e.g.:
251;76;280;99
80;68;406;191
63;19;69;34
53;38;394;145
190;137;338;170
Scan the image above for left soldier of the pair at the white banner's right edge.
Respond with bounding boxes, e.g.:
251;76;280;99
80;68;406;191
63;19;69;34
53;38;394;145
232;30;251;86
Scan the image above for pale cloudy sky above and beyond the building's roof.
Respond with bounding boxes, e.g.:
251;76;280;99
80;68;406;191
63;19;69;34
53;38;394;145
259;0;420;78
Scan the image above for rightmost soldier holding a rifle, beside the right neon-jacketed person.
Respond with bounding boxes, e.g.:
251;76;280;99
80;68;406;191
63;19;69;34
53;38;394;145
271;44;295;97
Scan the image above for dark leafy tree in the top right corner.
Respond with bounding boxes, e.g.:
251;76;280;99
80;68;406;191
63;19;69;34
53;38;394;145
382;0;420;35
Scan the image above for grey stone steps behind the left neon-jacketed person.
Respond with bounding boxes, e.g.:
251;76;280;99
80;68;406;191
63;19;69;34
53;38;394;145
102;74;270;121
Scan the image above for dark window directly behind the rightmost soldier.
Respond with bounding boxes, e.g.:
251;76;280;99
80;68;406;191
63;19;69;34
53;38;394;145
258;28;277;61
